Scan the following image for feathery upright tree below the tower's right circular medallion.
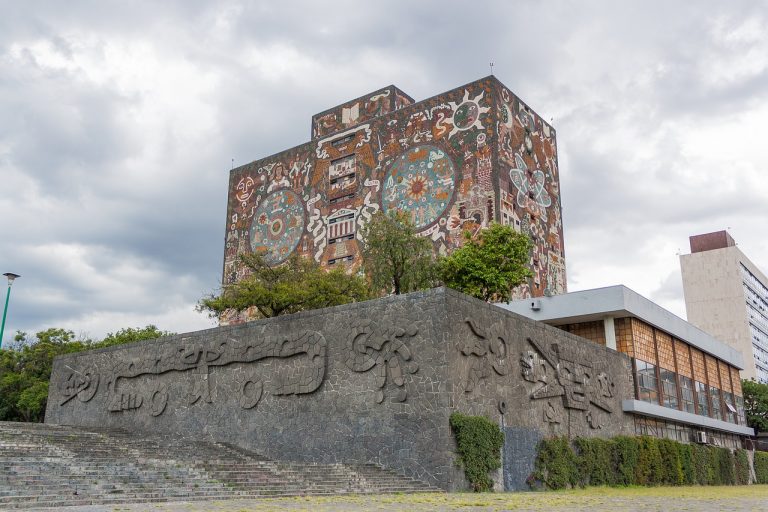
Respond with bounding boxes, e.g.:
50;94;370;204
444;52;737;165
362;212;438;295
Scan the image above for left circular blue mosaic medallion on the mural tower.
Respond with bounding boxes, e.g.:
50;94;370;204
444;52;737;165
250;189;304;265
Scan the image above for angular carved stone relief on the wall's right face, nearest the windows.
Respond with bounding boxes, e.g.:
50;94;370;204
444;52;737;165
520;338;615;429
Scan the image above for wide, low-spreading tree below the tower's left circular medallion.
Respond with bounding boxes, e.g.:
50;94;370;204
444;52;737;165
197;253;369;318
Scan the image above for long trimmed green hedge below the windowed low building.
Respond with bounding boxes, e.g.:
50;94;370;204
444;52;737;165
528;436;752;489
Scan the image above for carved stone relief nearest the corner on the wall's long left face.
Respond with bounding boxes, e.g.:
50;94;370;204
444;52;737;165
345;320;419;403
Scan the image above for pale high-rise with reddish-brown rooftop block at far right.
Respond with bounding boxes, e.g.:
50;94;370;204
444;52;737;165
680;231;768;383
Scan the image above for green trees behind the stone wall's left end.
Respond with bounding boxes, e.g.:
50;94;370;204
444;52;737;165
0;325;171;422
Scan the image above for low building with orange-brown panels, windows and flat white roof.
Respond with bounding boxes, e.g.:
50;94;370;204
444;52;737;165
498;286;754;448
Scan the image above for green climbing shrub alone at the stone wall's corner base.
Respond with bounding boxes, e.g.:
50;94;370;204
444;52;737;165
450;412;504;492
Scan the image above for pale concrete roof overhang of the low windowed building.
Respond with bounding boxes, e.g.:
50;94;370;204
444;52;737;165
496;285;744;370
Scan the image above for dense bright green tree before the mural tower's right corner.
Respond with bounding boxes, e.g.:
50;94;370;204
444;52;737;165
440;224;533;302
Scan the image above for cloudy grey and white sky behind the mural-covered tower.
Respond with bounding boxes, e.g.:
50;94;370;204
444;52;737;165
0;0;768;341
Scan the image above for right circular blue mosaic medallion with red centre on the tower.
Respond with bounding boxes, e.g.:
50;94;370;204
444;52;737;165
381;146;456;230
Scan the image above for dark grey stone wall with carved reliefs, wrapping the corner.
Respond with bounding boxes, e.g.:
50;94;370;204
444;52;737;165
45;288;633;490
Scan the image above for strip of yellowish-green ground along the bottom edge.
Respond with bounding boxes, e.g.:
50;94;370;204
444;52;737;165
21;485;768;512
